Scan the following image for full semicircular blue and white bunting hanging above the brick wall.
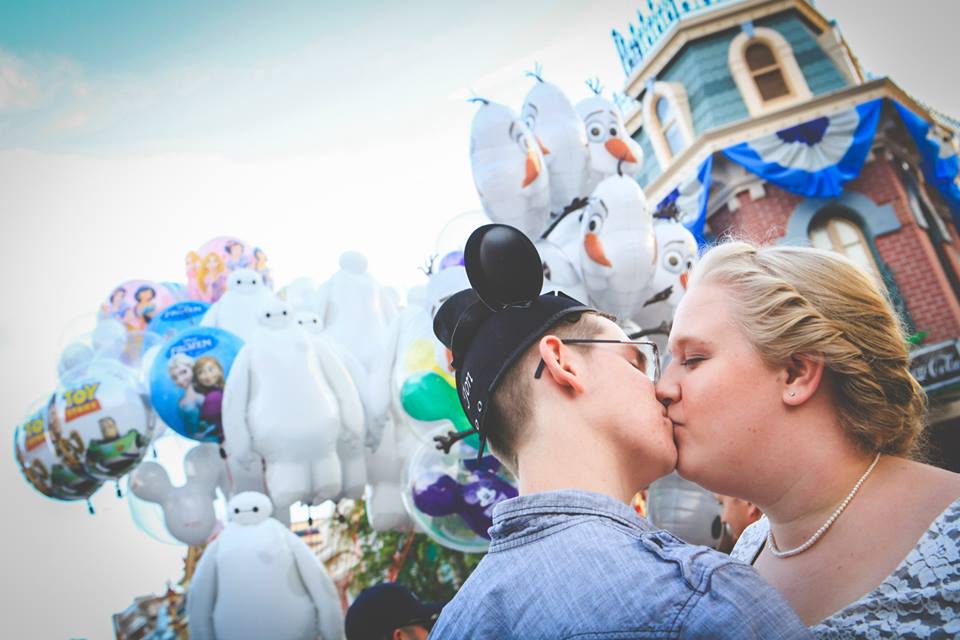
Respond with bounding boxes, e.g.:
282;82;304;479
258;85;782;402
723;100;883;198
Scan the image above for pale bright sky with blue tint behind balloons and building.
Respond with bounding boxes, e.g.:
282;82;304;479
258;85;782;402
0;0;960;638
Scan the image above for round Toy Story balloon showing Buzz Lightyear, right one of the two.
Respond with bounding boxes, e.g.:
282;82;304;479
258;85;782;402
47;372;154;480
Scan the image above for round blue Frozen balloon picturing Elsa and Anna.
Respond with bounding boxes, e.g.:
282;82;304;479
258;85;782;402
150;327;243;442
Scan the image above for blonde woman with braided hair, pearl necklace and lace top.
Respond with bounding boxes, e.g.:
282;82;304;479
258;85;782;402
657;242;960;638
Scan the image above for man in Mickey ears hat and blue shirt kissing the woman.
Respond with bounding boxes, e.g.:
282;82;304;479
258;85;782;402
430;224;812;640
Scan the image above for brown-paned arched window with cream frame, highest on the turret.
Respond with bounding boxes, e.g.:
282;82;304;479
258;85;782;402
728;27;813;117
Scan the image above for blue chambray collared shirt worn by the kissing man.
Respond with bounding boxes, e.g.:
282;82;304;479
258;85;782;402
430;491;812;640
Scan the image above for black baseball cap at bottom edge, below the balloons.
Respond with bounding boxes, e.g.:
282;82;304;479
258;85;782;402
346;582;443;640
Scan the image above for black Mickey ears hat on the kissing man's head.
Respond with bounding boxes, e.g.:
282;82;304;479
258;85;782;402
433;224;594;456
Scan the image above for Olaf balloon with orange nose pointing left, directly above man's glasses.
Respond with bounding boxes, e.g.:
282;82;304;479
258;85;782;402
580;176;657;318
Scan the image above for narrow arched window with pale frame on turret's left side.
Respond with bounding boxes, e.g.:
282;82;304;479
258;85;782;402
643;82;693;169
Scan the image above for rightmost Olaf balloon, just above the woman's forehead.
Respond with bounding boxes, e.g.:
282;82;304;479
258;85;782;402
632;217;697;353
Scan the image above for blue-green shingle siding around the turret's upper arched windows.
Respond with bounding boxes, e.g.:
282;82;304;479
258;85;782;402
634;10;848;186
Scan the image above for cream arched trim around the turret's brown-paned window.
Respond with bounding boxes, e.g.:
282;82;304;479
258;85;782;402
727;27;813;117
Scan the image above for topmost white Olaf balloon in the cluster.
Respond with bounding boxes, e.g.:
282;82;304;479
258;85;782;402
520;79;590;214
